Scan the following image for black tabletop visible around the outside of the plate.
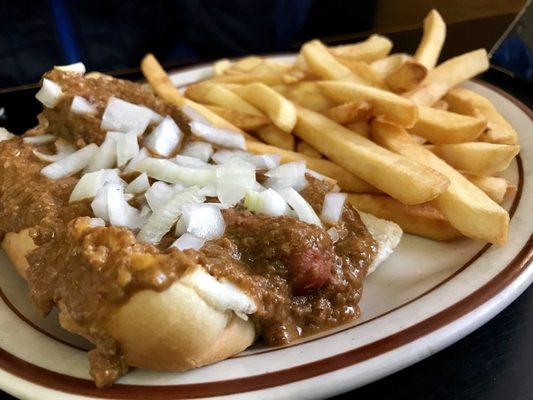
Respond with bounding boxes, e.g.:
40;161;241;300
0;66;533;400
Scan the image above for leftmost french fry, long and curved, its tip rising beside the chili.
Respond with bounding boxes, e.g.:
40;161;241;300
141;54;257;141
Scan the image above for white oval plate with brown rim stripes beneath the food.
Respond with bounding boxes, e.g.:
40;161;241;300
0;57;533;400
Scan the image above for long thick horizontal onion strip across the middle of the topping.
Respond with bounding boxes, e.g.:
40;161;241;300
135;157;217;186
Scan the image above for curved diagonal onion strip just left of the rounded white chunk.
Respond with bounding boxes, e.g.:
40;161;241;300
137;187;205;243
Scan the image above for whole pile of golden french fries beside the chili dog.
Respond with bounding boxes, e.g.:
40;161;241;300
141;10;520;245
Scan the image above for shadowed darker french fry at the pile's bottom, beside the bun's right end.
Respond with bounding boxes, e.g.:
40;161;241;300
348;193;463;241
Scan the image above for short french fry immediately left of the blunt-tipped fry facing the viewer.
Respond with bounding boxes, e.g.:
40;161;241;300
185;82;265;117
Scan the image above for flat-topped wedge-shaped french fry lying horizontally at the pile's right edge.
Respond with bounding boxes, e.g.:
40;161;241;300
426;142;520;175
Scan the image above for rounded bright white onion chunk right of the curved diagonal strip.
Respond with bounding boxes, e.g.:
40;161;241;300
181;203;226;240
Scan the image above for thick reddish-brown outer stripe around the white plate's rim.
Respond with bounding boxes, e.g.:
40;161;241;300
0;71;533;399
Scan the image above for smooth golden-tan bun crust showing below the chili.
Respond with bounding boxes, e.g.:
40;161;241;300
2;229;256;371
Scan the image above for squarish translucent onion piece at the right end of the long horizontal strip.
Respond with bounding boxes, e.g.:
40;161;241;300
217;159;255;205
